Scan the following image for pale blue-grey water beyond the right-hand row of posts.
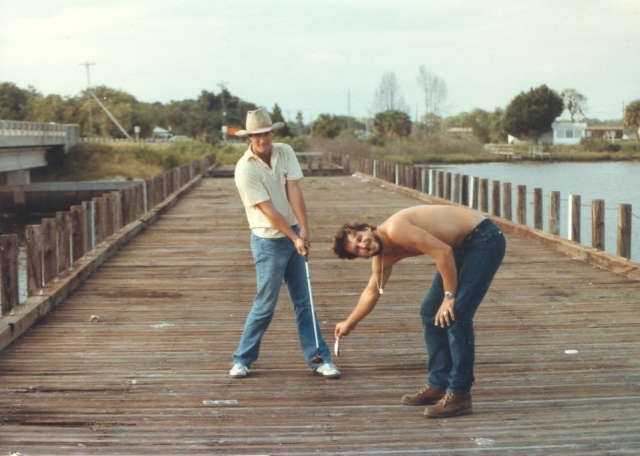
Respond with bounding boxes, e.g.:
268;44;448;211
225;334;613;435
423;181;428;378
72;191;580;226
439;161;640;262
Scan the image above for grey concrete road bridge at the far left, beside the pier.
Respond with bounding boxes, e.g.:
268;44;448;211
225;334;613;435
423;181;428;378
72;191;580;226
0;120;80;185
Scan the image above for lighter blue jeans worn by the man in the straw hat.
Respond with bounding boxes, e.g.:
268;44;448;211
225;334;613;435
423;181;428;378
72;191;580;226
233;225;331;370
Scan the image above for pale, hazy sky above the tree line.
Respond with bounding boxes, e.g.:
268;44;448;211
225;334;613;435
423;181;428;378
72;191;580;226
0;0;640;122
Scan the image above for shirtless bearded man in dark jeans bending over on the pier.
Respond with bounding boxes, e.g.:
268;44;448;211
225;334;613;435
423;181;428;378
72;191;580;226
333;205;506;418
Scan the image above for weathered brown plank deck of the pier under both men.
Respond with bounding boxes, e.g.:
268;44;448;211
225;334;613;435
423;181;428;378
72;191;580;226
0;176;640;455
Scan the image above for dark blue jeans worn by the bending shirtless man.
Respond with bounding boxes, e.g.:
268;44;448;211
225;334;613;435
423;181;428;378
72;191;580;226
420;219;506;394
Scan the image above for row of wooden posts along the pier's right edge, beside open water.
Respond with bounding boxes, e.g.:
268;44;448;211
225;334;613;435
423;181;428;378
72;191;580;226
340;155;640;279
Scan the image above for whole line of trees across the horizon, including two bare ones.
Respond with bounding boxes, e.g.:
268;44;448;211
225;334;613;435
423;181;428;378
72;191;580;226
0;78;640;144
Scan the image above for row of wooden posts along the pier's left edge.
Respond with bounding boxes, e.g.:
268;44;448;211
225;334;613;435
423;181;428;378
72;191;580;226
0;155;215;322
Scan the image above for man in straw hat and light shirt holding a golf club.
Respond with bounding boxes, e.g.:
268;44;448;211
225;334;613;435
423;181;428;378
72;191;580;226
229;108;340;378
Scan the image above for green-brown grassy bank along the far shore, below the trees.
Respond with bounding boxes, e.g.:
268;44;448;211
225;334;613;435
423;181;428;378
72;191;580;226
56;135;640;181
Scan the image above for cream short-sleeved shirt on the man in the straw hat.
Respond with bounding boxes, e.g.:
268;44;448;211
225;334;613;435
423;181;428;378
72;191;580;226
235;143;304;238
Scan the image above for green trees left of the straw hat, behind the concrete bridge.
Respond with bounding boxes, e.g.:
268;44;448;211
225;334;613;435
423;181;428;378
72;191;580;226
0;82;262;142
